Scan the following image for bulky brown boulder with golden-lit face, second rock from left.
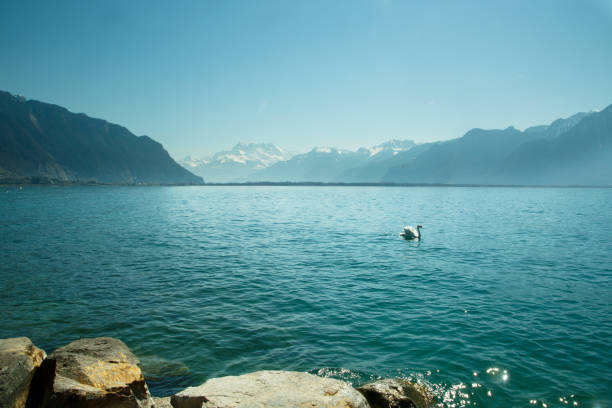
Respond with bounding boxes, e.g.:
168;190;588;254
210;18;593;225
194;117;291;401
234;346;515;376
40;337;154;408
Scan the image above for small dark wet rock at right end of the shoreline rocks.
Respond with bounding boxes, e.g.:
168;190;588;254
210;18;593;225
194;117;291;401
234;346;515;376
357;379;435;408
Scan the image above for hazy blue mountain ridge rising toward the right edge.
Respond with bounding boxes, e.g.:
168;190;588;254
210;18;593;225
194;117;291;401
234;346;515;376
380;105;612;185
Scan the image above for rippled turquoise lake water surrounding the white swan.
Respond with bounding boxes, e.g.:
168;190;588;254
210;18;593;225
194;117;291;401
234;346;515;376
0;187;612;407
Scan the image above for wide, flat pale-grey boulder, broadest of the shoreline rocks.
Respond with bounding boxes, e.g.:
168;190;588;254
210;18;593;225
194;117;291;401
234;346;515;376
171;371;369;408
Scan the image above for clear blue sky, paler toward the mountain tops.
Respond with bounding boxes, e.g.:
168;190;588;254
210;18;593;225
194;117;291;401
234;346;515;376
0;0;612;158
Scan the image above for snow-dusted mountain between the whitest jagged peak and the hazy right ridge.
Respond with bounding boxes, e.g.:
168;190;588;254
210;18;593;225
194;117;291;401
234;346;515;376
248;140;415;182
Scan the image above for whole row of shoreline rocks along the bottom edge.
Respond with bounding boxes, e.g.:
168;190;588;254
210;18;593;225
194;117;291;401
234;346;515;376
0;337;435;408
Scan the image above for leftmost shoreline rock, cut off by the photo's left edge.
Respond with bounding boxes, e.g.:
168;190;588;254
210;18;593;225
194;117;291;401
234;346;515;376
0;337;47;408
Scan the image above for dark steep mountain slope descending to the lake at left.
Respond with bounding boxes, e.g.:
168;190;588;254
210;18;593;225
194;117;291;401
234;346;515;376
0;91;203;184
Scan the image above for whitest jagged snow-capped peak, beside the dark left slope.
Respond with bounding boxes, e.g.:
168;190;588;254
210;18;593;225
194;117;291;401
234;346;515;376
178;143;295;183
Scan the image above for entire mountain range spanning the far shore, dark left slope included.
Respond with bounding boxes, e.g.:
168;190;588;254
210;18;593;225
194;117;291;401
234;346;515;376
0;91;612;186
